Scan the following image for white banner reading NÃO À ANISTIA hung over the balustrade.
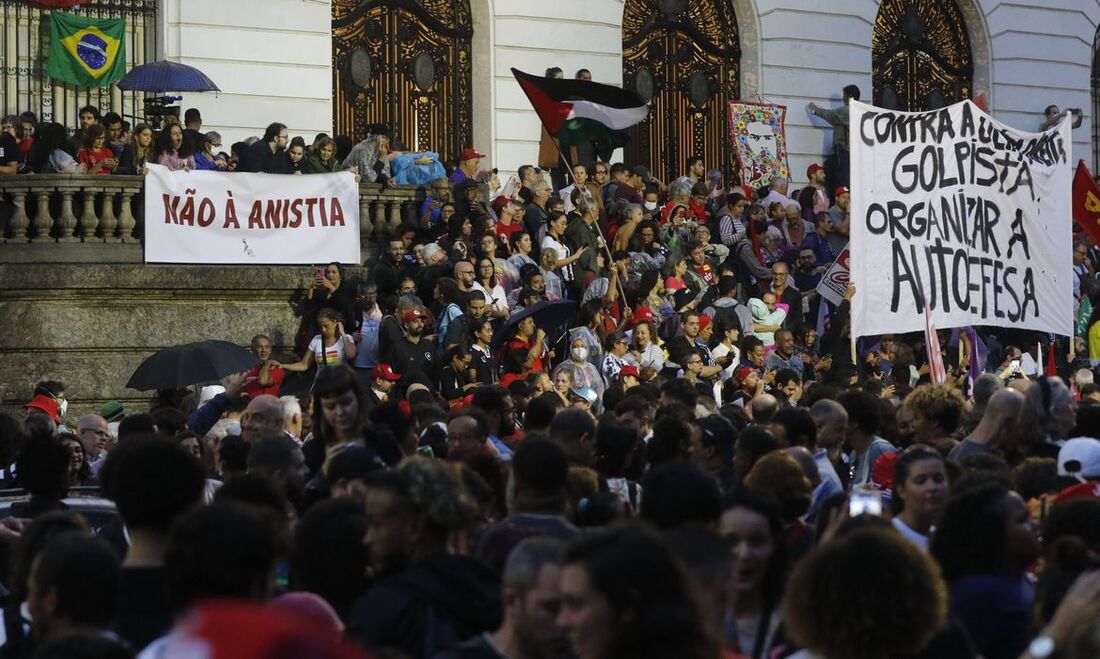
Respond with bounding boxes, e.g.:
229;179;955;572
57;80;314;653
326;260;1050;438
145;165;360;265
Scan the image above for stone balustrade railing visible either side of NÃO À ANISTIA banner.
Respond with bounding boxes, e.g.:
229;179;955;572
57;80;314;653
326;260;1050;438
0;174;426;243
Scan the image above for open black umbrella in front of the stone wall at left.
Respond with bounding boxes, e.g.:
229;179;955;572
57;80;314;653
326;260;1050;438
127;341;260;391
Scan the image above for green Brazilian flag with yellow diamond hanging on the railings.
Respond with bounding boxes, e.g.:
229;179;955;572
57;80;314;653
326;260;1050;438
46;11;127;87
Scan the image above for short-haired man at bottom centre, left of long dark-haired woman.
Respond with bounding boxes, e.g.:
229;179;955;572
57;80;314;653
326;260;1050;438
436;538;567;659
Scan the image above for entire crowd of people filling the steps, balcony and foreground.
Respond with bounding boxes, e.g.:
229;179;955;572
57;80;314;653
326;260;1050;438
0;89;1100;659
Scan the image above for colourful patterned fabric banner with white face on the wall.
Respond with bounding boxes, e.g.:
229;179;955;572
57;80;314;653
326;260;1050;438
729;101;790;188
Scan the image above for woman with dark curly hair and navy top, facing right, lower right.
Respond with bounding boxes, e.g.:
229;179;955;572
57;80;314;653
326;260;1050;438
928;482;1040;659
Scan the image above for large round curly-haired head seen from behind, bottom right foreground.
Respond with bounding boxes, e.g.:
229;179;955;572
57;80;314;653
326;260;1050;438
783;527;947;659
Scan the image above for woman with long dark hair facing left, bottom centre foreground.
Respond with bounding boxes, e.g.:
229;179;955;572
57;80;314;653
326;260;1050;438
558;526;718;659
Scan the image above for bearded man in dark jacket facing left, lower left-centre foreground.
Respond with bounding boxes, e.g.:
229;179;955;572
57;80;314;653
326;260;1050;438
348;458;501;657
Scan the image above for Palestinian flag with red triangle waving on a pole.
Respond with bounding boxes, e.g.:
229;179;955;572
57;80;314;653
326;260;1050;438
512;68;649;144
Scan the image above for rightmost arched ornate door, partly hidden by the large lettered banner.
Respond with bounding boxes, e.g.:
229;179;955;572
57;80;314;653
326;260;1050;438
871;0;974;112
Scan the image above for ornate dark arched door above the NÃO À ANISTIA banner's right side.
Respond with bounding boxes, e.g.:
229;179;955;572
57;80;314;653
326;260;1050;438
332;0;473;160
